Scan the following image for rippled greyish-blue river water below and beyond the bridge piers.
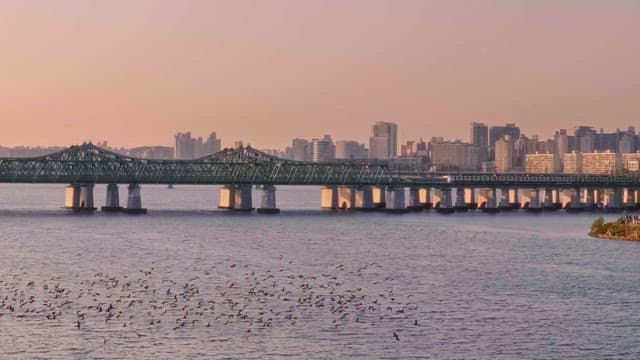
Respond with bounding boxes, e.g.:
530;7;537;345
0;185;640;359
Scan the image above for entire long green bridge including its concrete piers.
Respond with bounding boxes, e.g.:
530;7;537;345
0;143;640;213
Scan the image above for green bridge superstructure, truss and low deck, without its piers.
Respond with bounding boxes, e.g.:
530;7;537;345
0;143;640;188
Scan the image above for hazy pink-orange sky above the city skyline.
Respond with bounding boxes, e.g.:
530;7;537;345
0;0;640;148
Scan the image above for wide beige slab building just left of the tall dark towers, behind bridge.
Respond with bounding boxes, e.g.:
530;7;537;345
429;138;480;171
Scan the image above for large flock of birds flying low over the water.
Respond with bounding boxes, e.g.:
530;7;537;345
0;259;418;343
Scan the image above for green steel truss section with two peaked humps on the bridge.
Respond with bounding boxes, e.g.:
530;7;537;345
0;144;393;185
